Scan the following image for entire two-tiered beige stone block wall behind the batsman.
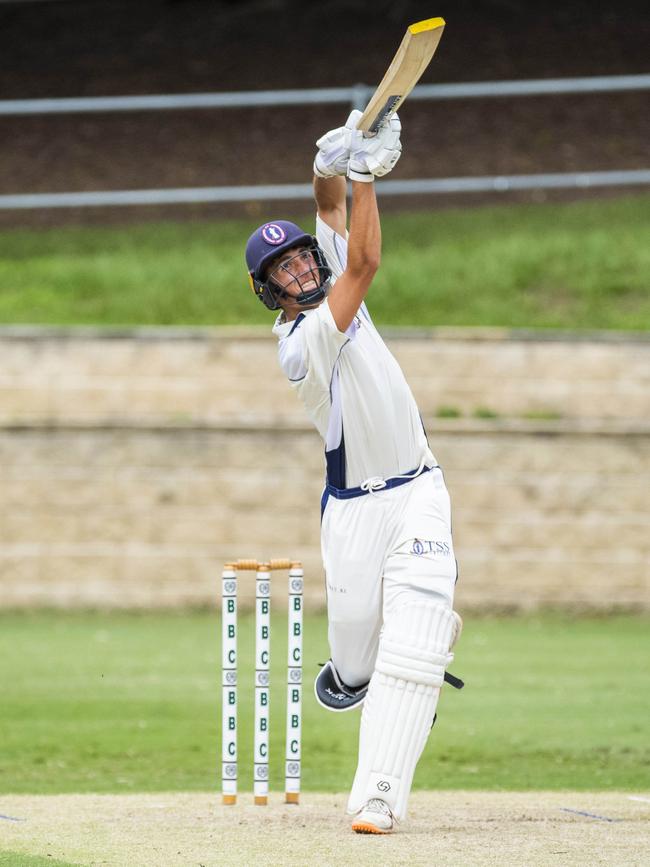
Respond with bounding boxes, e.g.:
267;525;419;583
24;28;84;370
0;330;650;609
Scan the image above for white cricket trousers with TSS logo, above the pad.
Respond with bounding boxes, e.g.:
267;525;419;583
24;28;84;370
321;467;457;686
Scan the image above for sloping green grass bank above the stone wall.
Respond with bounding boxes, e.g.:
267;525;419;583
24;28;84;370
0;195;650;329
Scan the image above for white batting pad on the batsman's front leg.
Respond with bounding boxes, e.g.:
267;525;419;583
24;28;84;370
348;602;457;820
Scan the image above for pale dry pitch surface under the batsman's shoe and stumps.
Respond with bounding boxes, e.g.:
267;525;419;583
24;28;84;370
0;792;650;867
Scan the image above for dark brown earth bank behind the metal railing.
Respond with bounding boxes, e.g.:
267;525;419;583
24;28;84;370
0;0;650;225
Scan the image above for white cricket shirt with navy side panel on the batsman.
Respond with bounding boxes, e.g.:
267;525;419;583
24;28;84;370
273;217;436;488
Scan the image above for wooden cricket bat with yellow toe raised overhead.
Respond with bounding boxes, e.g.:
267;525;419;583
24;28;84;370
357;18;445;134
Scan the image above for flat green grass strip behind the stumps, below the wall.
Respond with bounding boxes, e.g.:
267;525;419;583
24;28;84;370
0;612;650;792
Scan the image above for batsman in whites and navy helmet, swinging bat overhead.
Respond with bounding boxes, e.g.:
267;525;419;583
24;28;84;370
246;111;461;834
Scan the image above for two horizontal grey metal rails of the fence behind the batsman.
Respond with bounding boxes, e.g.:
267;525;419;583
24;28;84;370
0;74;650;210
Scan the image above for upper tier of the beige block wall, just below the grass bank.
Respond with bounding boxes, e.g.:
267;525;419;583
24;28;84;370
0;328;650;425
